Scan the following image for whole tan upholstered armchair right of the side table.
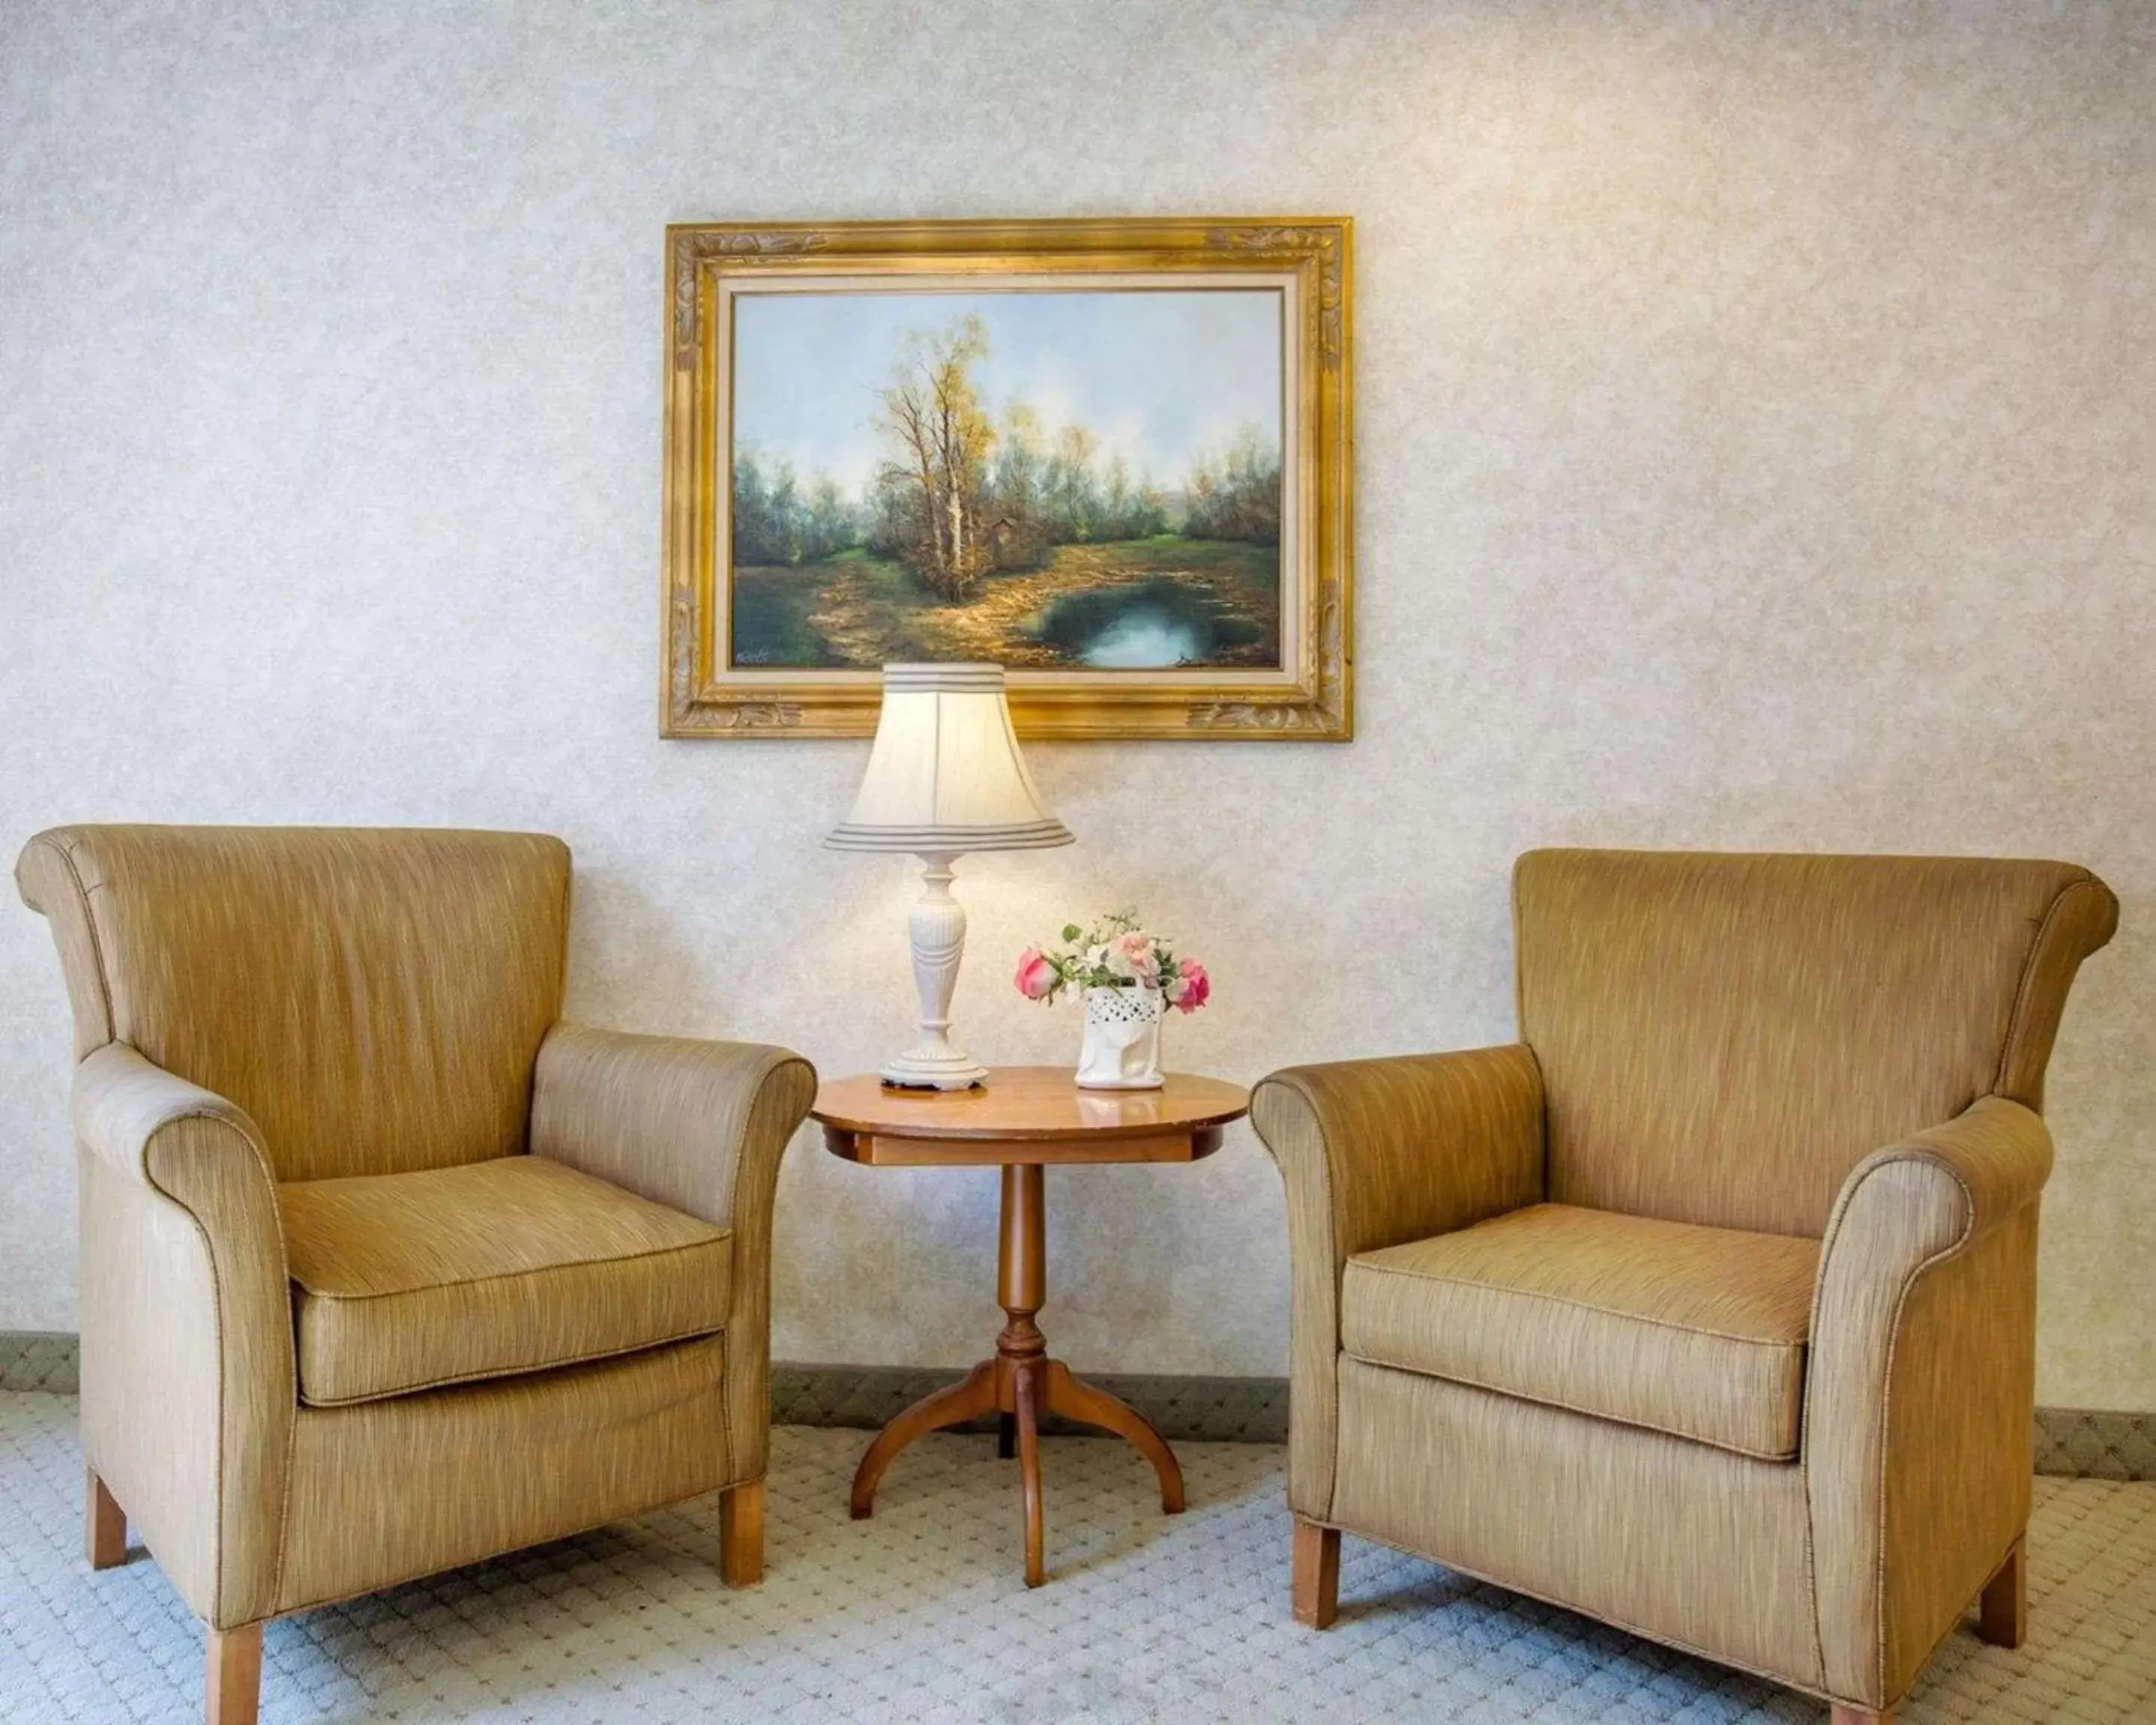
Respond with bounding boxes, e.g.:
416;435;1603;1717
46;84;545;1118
1252;852;2117;1721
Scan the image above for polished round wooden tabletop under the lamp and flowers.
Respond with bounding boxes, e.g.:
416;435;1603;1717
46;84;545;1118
811;1065;1250;1166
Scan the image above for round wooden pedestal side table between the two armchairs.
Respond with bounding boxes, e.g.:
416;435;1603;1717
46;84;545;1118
813;1065;1250;1587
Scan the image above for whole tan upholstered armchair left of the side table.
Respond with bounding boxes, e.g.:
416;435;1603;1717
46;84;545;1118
17;826;815;1725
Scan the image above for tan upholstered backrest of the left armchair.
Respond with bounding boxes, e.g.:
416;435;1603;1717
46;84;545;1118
15;826;569;1179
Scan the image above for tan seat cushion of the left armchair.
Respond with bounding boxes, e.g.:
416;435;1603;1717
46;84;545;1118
278;1156;733;1408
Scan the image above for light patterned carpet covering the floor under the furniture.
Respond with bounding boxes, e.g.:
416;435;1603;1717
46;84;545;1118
0;1393;2156;1725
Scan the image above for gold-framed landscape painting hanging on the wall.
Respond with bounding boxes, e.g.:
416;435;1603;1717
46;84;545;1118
660;218;1352;742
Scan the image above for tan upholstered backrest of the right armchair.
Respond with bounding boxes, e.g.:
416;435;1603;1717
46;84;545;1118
1514;850;2117;1235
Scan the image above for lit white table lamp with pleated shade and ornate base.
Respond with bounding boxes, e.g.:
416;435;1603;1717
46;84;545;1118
823;664;1071;1091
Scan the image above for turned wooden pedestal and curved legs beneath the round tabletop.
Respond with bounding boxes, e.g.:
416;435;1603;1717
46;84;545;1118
853;1162;1184;1587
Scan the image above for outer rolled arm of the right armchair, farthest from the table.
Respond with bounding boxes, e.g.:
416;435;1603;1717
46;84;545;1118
1805;1095;2053;1708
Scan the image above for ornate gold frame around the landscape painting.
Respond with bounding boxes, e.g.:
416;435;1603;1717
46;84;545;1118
660;216;1354;742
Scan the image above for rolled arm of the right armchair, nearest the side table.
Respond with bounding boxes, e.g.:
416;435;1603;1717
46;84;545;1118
1250;1044;1544;1520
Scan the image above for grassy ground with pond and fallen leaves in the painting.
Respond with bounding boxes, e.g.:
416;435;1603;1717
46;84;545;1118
733;532;1281;671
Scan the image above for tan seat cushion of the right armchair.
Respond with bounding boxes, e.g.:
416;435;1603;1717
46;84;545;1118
1341;1203;1820;1460
